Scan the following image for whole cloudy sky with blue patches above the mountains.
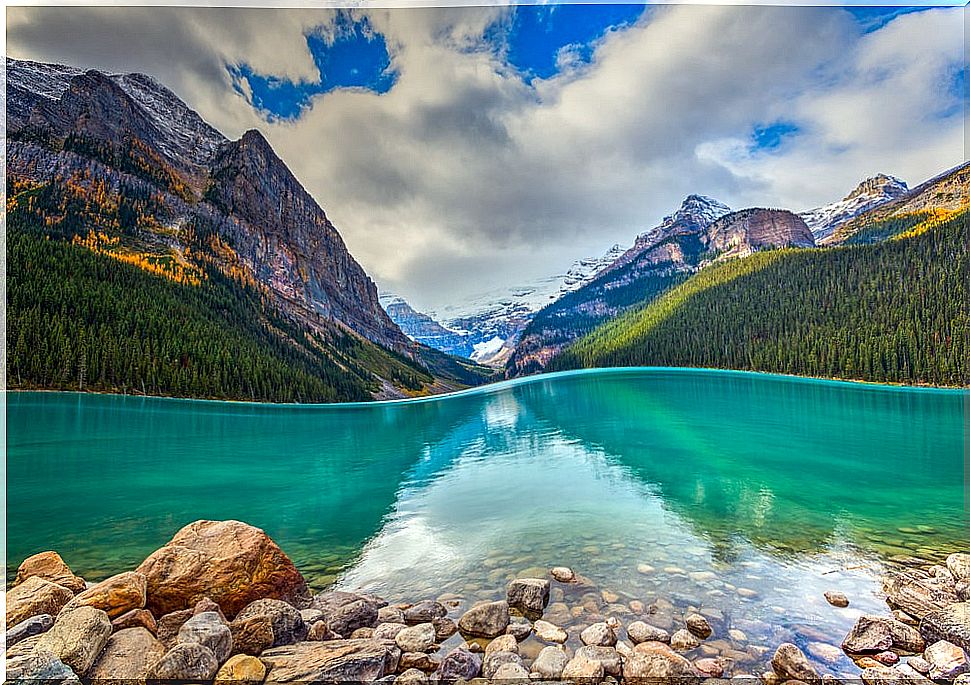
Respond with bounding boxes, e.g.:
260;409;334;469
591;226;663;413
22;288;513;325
7;5;966;309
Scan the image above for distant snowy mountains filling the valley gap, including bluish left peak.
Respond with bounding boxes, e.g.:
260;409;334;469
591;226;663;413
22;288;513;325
381;245;625;366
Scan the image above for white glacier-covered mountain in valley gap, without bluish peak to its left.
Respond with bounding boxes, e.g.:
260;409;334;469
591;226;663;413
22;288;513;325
420;245;623;367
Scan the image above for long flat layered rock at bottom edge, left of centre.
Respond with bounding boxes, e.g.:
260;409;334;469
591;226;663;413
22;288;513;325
260;640;401;683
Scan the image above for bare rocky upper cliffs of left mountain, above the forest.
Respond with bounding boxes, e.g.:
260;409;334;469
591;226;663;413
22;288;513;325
7;59;414;356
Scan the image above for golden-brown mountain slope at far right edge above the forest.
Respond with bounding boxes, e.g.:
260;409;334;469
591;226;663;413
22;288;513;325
821;162;970;245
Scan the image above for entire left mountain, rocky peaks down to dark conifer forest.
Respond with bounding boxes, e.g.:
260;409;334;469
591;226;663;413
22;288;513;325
6;58;487;401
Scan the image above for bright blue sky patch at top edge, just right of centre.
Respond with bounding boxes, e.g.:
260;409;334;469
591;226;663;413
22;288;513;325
487;4;645;79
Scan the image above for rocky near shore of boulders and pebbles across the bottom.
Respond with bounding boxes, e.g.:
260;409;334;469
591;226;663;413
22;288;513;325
6;521;970;685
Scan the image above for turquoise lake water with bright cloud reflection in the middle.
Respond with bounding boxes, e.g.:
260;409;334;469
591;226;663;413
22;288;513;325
6;369;970;673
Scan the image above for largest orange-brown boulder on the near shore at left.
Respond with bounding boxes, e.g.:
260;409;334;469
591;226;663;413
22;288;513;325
136;521;308;616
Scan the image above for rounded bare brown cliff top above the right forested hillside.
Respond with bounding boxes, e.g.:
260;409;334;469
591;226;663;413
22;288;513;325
706;209;815;259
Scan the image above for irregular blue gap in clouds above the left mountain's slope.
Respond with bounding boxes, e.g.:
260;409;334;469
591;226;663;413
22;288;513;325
226;11;397;121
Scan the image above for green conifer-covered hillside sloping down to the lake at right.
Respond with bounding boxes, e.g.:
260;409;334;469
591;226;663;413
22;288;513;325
548;210;970;386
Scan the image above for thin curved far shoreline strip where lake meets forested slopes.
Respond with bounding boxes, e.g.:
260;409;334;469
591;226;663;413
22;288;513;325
5;366;970;409
